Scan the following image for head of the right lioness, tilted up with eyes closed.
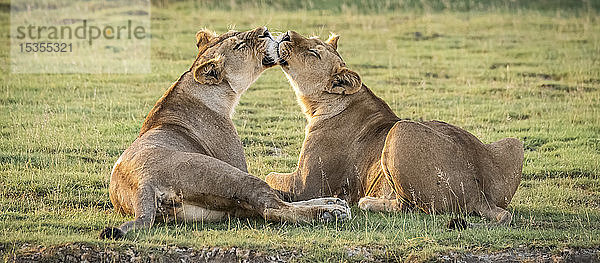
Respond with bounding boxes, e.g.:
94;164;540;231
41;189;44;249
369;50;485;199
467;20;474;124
278;31;362;100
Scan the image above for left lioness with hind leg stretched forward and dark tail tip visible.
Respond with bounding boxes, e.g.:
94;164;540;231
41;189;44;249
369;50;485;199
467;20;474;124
101;27;350;238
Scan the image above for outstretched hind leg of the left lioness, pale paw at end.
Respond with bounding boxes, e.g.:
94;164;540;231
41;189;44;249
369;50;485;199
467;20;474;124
166;153;351;225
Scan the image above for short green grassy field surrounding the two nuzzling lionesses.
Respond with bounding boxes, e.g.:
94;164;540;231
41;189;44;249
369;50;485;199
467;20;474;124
0;0;600;261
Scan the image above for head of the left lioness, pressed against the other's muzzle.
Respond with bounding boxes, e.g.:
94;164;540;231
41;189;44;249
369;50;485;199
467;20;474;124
192;27;277;93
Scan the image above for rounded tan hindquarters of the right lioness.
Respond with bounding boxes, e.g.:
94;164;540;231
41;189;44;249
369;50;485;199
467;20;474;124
382;121;521;212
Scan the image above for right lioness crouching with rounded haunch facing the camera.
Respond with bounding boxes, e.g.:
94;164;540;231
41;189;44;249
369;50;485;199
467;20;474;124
266;31;523;224
